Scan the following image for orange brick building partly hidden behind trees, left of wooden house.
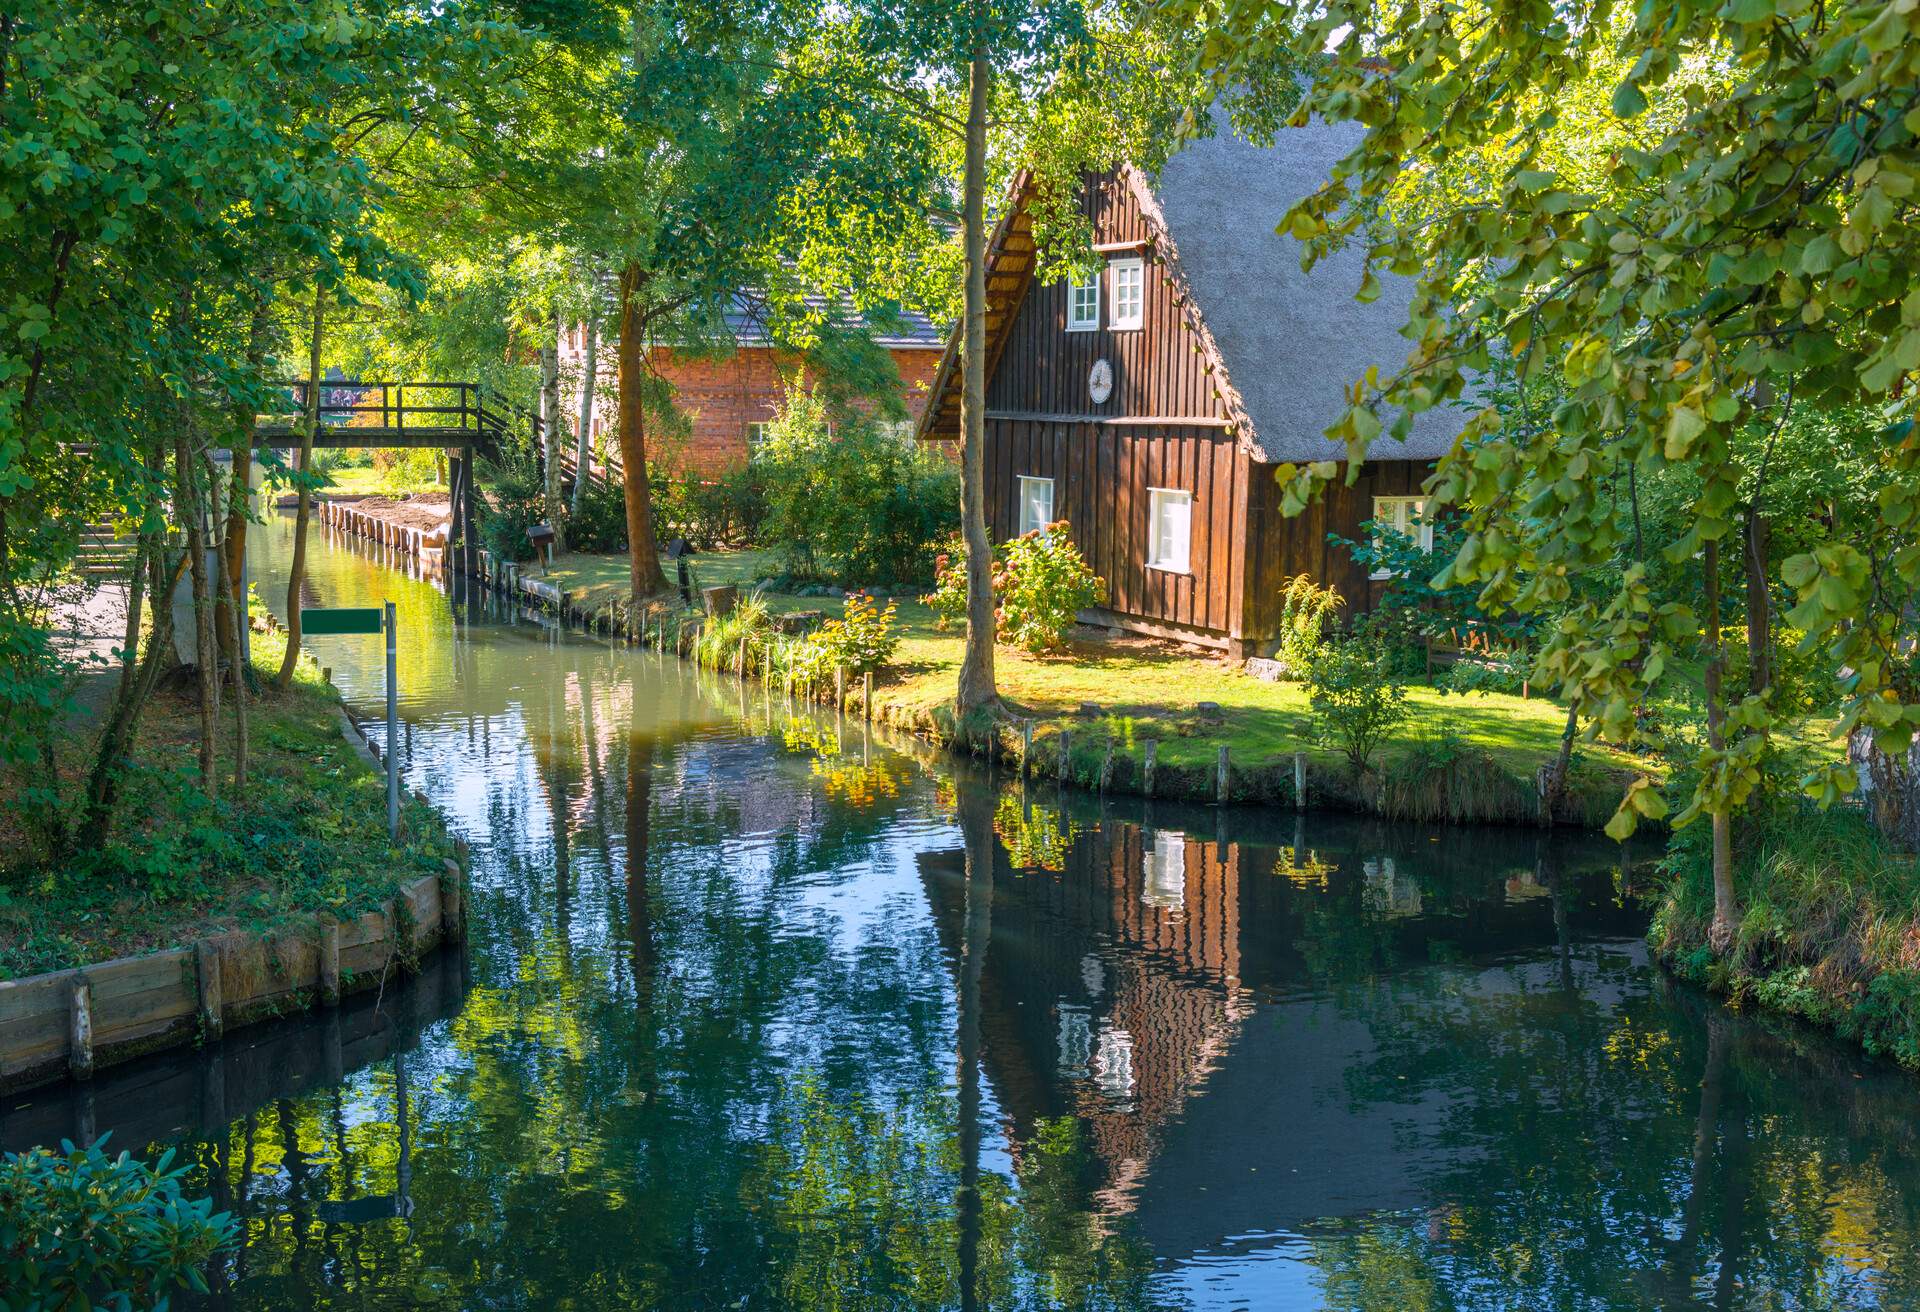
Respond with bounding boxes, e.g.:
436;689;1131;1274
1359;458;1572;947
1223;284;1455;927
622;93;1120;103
561;304;947;474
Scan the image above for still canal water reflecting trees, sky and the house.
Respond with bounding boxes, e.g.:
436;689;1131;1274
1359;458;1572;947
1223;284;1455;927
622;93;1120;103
0;524;1920;1310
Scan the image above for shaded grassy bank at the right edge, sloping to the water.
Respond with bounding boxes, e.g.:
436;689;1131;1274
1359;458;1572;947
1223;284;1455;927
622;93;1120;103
1649;807;1920;1070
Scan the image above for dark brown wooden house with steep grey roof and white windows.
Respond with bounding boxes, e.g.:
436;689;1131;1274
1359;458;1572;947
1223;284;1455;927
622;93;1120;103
920;121;1465;657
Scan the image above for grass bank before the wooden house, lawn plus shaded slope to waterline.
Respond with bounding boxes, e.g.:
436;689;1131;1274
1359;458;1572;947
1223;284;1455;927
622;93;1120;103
534;551;1661;828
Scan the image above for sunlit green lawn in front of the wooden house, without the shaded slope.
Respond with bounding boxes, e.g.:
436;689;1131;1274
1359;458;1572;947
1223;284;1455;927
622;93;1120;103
540;551;1689;795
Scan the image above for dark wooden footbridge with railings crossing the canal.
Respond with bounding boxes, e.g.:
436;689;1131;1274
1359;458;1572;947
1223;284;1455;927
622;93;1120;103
253;378;543;576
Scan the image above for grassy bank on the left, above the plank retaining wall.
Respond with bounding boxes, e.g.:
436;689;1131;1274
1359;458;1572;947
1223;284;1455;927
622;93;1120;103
0;632;453;980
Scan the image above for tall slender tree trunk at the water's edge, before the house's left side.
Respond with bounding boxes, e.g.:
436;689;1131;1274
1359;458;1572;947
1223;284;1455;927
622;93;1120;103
954;42;1000;718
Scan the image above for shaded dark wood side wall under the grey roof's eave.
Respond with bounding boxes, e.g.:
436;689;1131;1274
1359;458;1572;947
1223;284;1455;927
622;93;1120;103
1244;461;1432;638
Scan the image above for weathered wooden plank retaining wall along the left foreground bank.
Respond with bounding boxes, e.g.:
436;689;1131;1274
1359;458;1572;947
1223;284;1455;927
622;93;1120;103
0;861;465;1093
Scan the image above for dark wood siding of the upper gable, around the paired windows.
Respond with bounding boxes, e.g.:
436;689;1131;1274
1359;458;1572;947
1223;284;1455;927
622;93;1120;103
987;175;1227;421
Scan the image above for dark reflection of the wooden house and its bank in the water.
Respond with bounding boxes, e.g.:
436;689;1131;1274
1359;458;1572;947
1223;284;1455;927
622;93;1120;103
920;809;1642;1260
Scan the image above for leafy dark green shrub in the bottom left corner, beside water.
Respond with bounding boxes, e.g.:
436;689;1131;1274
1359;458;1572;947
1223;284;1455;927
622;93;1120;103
0;1139;236;1308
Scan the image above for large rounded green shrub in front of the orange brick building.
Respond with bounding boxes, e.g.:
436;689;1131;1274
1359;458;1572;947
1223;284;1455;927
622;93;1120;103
753;388;960;586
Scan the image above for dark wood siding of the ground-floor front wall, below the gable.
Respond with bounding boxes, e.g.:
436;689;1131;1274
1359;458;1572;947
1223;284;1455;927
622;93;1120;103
985;419;1248;636
